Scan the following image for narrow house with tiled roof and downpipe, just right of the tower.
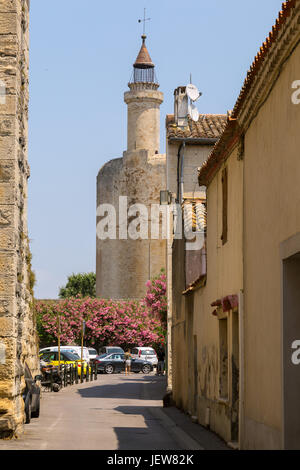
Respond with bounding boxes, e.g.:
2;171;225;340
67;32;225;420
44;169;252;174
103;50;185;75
166;105;227;390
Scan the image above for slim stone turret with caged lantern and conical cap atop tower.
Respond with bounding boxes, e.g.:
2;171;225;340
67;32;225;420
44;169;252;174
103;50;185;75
124;34;163;153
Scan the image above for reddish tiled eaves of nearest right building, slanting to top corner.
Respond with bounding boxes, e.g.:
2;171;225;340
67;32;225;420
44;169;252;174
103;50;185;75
199;0;300;186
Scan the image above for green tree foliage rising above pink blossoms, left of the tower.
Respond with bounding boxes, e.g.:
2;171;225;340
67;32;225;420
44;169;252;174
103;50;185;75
59;273;96;299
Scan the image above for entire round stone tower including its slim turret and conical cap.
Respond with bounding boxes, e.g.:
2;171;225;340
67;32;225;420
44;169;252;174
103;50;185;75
96;35;166;299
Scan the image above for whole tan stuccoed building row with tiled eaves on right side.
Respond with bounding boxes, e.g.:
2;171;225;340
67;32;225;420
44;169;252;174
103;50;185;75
173;0;300;449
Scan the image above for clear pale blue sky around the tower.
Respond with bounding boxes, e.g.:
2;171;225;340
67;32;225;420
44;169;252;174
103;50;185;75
28;0;281;298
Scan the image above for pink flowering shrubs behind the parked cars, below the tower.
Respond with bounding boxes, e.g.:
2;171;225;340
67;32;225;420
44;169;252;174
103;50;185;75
35;273;167;349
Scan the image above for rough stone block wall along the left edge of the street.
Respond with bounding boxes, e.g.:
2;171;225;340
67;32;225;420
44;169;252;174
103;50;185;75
0;0;38;437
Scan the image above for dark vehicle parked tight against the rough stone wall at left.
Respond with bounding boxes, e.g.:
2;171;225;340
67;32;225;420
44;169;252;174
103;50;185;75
23;364;41;424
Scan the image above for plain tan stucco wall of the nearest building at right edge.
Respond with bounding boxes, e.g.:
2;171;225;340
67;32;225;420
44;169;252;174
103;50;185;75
243;9;300;449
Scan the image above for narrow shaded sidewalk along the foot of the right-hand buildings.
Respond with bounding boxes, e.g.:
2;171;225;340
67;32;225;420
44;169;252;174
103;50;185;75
146;377;231;450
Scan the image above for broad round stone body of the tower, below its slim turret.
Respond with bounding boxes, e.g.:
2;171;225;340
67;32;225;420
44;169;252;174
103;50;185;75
96;150;166;299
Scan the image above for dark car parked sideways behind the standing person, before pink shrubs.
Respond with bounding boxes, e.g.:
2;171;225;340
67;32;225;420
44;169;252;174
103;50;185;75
95;354;153;374
